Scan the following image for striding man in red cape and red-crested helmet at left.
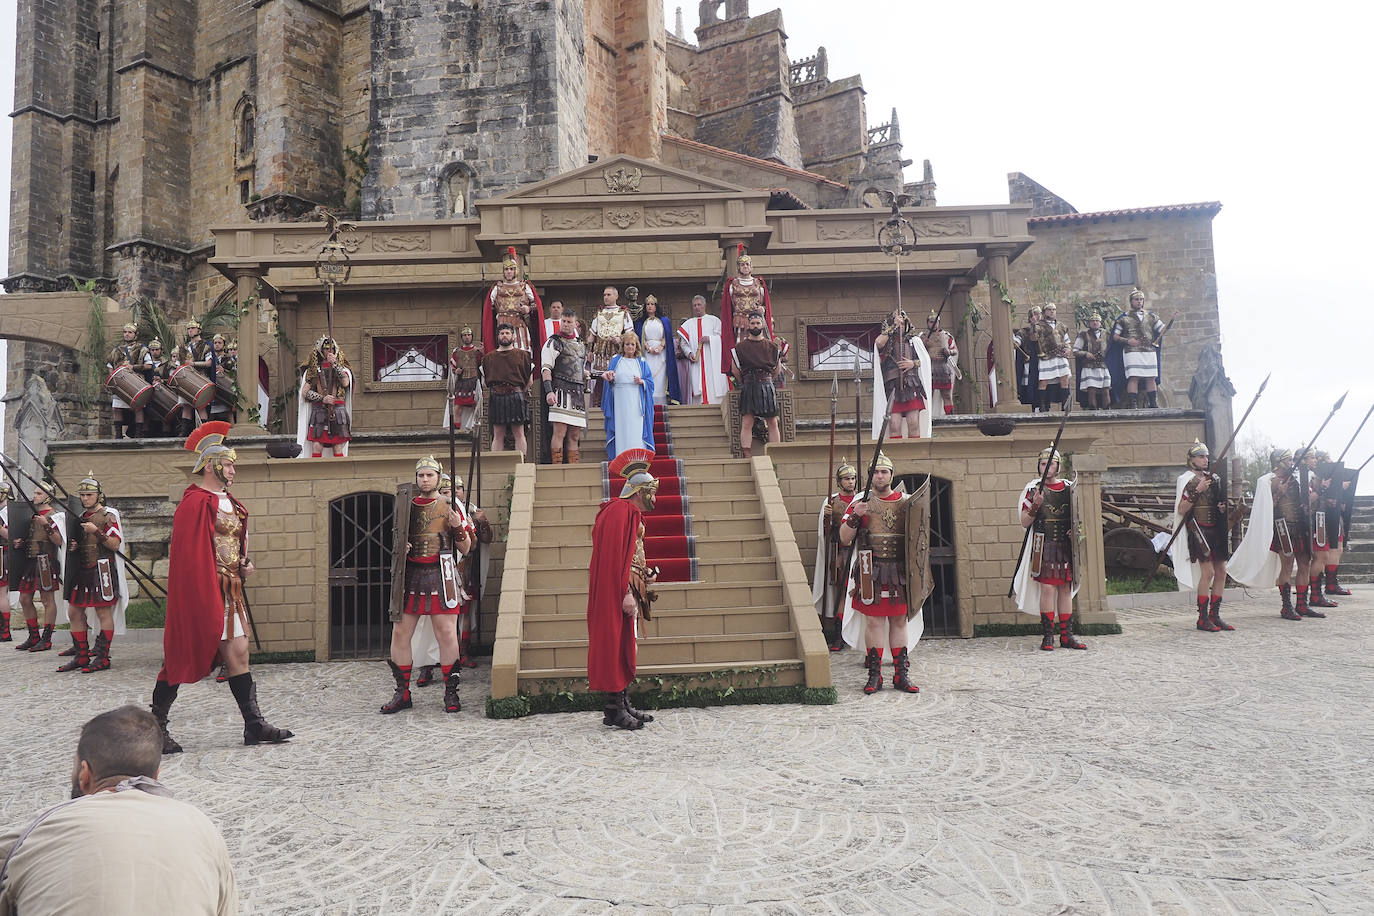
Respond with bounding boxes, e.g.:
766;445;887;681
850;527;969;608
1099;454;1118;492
151;420;291;754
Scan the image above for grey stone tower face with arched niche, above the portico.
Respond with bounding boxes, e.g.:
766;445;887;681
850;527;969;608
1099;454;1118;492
363;0;587;220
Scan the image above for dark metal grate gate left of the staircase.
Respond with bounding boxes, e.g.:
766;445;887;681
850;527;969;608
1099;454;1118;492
330;493;396;658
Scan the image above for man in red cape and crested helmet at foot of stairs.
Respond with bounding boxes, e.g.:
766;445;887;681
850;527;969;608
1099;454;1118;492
587;449;658;731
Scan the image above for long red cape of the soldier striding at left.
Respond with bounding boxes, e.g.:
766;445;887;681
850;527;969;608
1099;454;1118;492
162;483;232;684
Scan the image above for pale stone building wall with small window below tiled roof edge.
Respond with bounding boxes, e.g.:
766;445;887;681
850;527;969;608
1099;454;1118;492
1007;211;1221;408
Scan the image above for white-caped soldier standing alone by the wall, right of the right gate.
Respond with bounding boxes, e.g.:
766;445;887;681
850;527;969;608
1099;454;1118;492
1013;446;1087;652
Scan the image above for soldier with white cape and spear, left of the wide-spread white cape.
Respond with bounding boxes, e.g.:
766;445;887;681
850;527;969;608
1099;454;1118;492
1169;439;1235;633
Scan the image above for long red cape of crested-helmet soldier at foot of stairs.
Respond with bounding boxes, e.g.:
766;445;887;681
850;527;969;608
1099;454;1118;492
587;499;642;694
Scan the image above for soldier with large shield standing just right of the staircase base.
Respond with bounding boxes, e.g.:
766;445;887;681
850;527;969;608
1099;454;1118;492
840;453;926;694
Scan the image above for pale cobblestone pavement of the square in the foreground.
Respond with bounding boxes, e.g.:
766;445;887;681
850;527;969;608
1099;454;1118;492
0;586;1374;913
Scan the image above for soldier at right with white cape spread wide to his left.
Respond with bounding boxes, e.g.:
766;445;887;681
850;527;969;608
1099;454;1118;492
1227;449;1326;621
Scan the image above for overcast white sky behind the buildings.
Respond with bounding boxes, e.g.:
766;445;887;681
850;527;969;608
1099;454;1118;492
0;0;1374;493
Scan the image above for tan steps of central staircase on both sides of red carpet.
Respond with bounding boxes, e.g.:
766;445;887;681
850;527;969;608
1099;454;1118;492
493;405;830;696
